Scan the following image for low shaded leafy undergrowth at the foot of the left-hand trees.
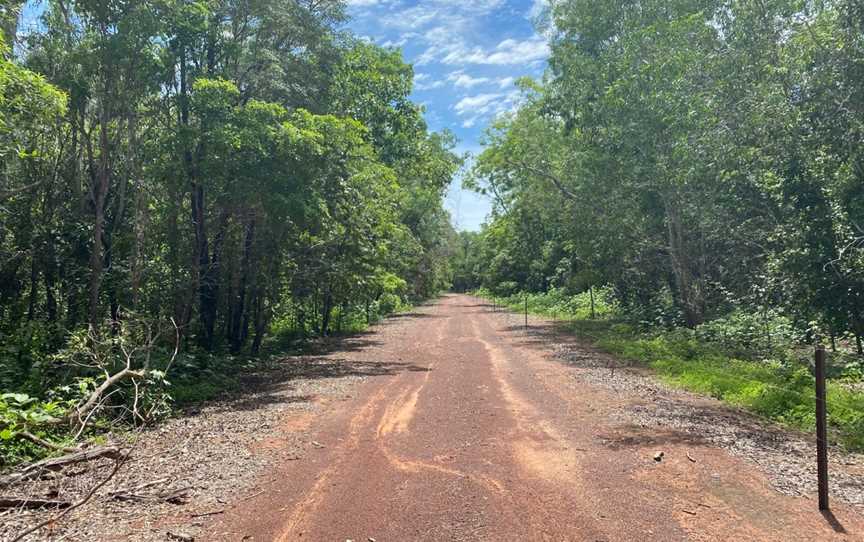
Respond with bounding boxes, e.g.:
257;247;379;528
0;294;412;471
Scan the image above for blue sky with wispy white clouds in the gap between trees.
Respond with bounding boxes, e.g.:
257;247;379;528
348;0;549;230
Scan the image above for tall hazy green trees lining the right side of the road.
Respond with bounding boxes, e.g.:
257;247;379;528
462;0;864;353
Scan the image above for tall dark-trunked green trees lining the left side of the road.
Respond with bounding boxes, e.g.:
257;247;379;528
0;0;460;393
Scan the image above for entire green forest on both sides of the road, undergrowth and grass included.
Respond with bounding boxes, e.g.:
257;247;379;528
0;0;864;470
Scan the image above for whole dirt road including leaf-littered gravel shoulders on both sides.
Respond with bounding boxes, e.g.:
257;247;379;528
0;295;864;542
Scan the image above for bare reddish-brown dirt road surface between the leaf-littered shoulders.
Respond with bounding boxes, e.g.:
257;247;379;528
203;296;864;542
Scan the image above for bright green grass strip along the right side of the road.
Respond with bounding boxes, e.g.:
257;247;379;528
476;295;864;451
